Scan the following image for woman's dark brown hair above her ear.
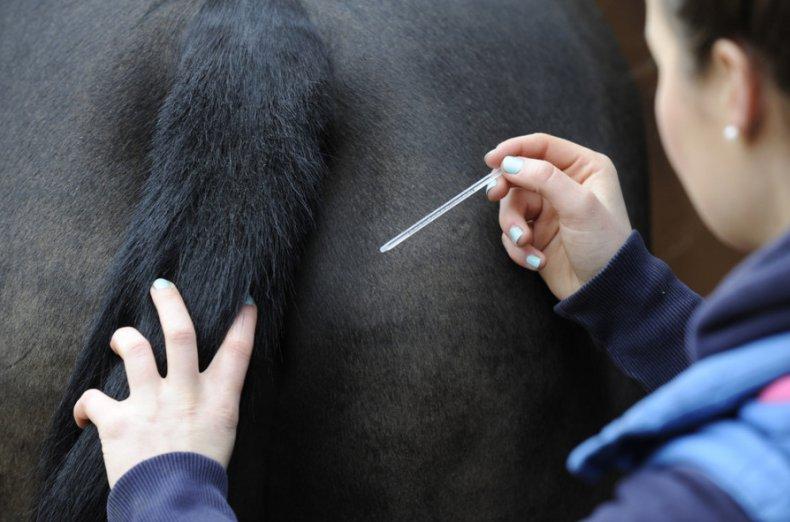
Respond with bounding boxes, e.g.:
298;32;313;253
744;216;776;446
667;0;790;93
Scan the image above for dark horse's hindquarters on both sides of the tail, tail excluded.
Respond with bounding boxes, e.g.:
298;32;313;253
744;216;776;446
0;0;645;520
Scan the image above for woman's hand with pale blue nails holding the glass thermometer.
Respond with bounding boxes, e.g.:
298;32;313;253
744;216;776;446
485;134;631;299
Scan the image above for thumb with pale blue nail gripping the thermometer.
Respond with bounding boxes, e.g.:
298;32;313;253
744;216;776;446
502;156;600;221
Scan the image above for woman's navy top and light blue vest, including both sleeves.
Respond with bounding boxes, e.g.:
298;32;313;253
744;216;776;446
107;232;790;522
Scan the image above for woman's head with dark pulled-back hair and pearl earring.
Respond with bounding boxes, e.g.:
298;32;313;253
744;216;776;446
646;0;790;250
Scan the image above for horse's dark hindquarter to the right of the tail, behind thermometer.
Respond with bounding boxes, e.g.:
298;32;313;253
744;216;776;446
269;0;643;520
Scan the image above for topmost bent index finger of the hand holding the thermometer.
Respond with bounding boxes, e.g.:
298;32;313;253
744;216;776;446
485;133;603;170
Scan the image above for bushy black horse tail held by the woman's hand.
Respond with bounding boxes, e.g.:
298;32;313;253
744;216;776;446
33;0;332;520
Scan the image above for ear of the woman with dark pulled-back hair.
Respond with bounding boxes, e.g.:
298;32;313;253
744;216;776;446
711;38;762;139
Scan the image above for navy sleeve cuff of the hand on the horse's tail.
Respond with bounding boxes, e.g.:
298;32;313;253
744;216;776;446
107;452;236;522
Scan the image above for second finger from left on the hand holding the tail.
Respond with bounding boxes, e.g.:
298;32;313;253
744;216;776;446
110;326;161;393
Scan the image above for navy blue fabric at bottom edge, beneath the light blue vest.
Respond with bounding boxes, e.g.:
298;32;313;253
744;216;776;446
584;468;749;522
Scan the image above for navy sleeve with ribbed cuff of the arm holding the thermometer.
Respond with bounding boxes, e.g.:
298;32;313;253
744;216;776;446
554;230;702;390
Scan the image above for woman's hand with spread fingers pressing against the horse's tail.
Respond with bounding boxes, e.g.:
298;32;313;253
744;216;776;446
74;279;257;487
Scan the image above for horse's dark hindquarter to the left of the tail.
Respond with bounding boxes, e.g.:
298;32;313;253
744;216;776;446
0;0;190;520
